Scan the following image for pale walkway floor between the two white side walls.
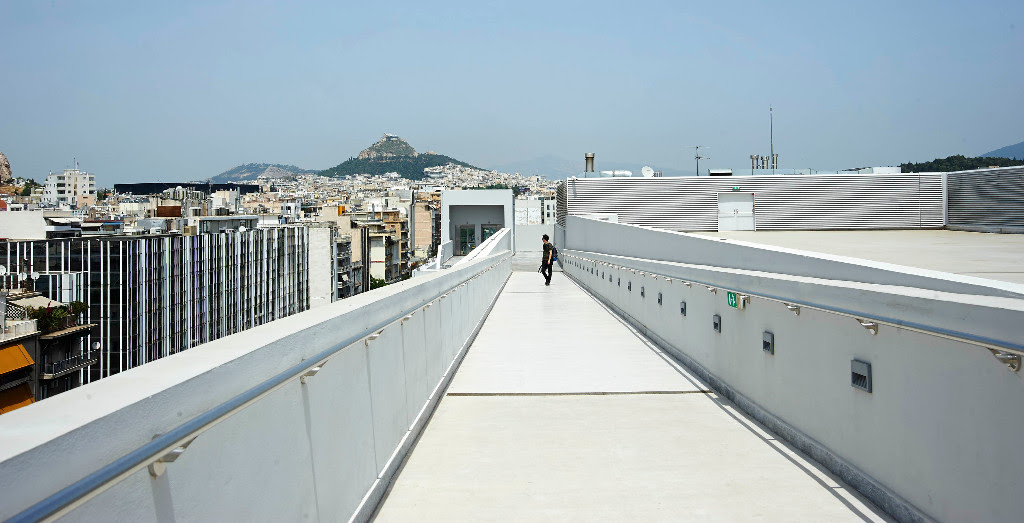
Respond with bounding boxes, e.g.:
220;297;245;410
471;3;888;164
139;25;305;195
376;264;886;521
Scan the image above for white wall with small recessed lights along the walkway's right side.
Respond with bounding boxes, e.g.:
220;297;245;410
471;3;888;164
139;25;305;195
563;215;1024;521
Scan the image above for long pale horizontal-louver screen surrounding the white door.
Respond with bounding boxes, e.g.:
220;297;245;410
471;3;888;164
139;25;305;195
565;174;944;230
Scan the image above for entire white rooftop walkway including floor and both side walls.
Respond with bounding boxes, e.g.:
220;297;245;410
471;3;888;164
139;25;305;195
0;225;1024;521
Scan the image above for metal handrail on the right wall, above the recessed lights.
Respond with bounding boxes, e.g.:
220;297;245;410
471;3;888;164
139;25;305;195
565;254;1024;356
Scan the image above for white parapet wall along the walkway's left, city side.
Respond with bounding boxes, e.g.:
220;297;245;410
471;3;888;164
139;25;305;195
0;251;511;521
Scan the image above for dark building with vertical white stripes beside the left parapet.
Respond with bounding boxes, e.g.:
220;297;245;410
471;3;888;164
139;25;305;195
0;226;309;383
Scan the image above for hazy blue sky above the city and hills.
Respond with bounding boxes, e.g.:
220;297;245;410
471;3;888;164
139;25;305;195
0;0;1024;186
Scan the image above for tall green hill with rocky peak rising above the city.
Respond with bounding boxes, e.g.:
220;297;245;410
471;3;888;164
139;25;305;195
319;134;483;180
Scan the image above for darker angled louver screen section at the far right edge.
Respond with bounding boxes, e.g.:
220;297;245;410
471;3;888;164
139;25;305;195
947;167;1024;228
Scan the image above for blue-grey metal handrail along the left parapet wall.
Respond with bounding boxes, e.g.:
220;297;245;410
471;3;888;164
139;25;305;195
14;253;504;523
